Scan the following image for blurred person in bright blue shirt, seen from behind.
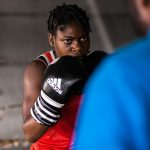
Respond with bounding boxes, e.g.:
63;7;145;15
74;0;150;150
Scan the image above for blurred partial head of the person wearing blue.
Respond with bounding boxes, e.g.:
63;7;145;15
129;0;150;32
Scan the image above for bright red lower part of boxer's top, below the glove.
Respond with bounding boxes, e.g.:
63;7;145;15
30;95;82;150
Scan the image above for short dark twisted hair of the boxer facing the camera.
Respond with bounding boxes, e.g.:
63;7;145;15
47;3;91;35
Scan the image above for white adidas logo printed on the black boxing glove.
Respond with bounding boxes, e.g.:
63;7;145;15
47;78;62;94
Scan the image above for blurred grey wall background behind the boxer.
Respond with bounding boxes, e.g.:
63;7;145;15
0;0;140;150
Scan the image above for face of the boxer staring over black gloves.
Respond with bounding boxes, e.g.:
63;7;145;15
49;22;90;57
